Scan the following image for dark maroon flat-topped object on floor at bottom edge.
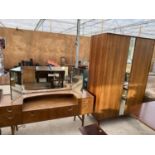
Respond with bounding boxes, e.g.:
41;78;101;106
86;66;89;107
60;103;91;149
79;124;107;135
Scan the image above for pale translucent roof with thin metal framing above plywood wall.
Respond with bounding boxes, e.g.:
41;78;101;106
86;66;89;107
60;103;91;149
0;19;155;38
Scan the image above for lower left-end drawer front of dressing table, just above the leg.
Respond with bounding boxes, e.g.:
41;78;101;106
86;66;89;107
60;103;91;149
0;114;22;127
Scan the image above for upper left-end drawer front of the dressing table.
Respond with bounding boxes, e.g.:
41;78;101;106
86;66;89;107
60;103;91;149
0;105;22;116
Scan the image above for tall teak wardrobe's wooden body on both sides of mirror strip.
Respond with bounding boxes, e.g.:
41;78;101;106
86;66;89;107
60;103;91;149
88;33;154;120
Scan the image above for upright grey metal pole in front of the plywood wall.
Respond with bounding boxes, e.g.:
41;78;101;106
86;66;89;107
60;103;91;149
75;19;80;68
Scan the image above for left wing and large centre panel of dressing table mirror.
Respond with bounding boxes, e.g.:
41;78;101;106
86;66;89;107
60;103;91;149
10;66;74;99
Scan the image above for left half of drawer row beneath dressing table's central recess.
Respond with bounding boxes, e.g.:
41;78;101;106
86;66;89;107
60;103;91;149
22;110;48;123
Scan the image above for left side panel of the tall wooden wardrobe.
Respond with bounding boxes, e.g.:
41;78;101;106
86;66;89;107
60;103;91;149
88;34;107;111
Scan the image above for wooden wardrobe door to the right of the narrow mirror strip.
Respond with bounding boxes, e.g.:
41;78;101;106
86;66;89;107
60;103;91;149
126;38;154;113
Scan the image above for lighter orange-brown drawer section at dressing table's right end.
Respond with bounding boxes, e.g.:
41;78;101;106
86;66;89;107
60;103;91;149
79;98;94;114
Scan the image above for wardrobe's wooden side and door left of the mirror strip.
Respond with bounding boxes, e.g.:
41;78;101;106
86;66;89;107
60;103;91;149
88;34;130;119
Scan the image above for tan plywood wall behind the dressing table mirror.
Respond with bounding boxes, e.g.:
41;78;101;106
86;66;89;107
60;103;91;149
0;28;90;68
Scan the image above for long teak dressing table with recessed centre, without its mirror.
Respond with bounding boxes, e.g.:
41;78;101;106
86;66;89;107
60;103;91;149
0;90;94;134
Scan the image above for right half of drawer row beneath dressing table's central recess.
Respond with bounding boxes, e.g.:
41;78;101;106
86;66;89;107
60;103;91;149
49;105;78;119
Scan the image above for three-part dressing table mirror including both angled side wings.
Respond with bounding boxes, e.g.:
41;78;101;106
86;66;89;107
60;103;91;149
10;65;88;100
